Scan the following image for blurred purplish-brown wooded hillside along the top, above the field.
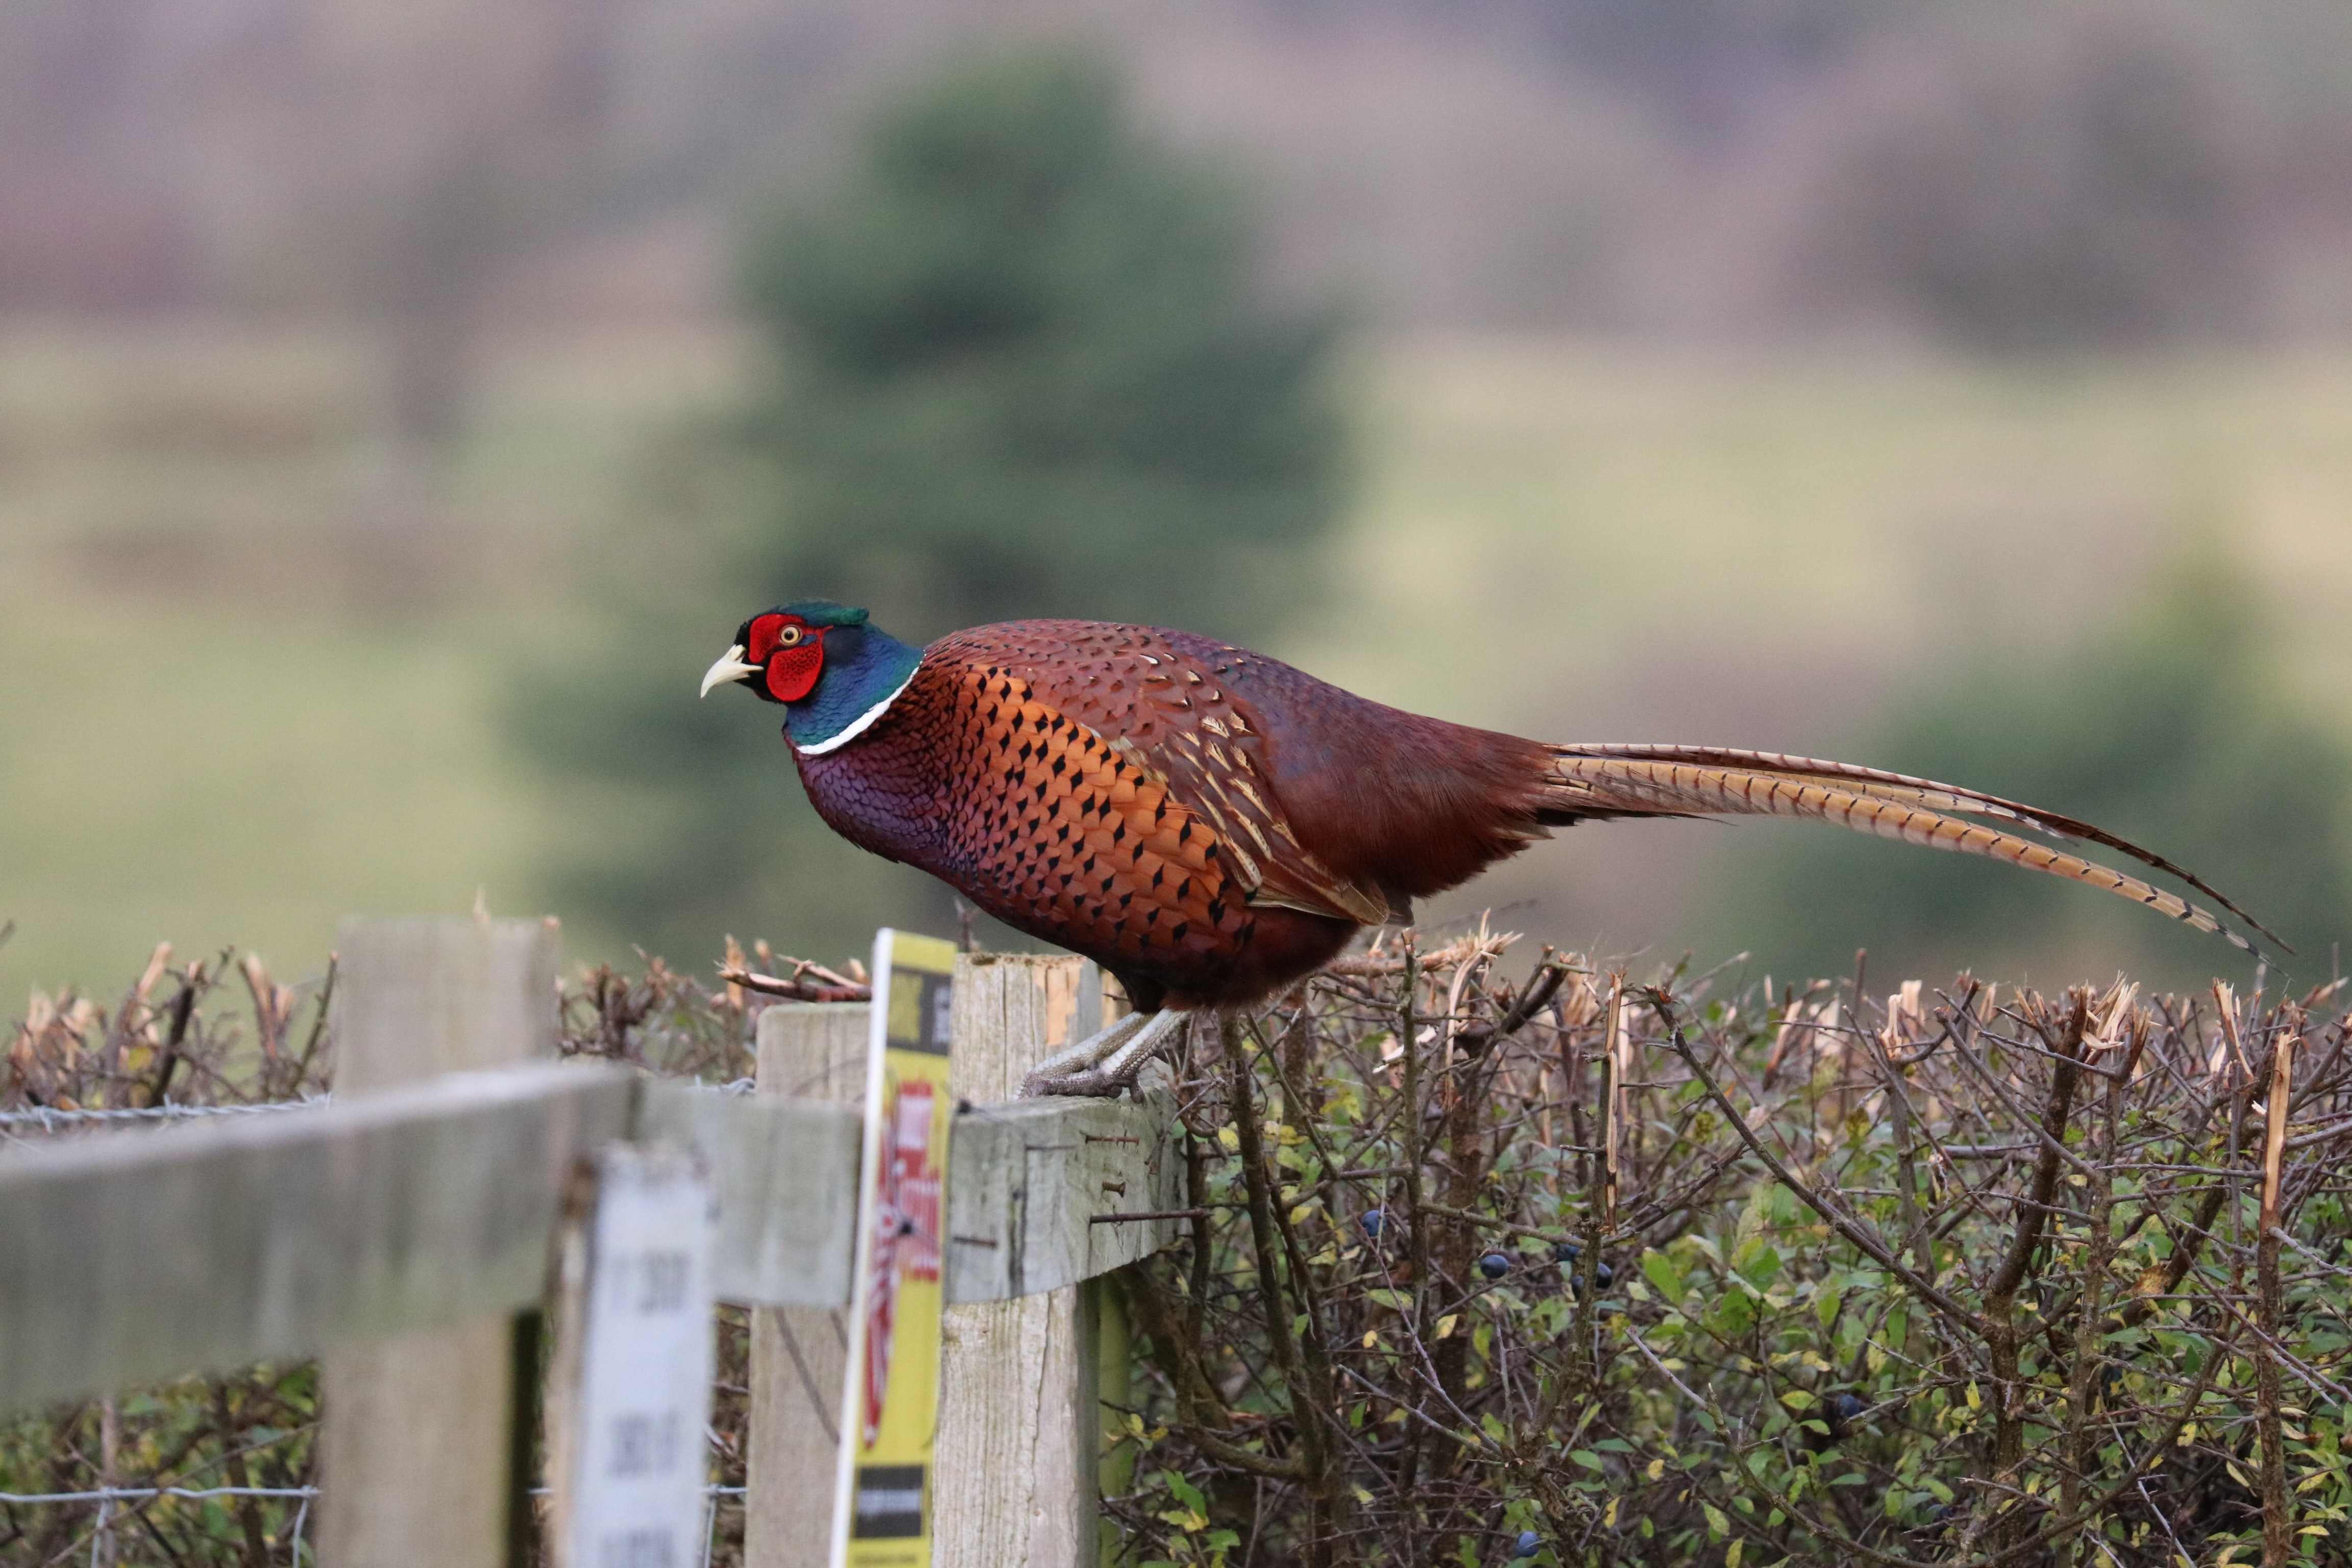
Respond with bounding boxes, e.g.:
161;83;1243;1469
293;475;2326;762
14;0;2352;340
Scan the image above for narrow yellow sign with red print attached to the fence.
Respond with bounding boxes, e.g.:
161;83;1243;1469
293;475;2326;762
832;928;955;1568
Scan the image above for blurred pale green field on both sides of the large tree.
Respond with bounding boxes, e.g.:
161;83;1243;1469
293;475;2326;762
0;327;2352;1009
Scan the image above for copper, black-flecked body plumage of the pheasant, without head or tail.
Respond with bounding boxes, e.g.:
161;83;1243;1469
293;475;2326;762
795;621;1505;1006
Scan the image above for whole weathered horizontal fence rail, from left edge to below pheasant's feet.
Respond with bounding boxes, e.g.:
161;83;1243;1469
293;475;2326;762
0;1063;1183;1408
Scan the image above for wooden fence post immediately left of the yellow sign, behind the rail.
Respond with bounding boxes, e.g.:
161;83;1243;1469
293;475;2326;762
743;1001;873;1568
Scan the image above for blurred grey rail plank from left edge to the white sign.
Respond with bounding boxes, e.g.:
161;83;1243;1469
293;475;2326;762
0;1063;635;1408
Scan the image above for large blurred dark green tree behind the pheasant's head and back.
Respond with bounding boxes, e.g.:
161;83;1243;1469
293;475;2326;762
520;52;1341;957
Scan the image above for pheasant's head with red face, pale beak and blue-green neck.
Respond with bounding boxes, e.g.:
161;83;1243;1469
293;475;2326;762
703;599;922;754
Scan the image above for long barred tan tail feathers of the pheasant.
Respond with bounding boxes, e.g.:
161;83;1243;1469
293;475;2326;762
1543;745;2293;957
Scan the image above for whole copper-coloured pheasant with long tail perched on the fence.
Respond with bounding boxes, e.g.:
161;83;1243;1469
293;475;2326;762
703;599;2284;1093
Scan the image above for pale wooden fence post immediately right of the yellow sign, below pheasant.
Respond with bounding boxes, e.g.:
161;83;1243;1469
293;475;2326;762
932;952;1101;1568
